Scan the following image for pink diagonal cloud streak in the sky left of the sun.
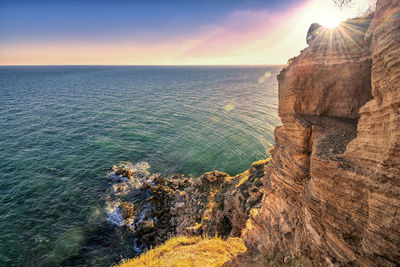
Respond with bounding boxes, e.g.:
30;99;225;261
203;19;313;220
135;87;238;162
182;2;308;58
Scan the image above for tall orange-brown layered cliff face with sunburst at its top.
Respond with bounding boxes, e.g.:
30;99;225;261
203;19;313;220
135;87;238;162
241;0;400;266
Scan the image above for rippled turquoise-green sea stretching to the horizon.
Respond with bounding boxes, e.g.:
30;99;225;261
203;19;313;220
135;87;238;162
0;66;280;266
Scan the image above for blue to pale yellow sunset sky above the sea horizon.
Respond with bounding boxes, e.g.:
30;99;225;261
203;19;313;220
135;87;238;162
0;0;374;65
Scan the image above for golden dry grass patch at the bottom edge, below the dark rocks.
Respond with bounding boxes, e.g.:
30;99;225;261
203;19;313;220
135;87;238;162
120;236;246;267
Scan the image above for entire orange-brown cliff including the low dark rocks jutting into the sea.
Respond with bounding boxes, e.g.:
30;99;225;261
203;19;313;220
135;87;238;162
114;0;400;266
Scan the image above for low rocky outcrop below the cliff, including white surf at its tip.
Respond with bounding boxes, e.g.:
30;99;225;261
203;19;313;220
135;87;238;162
108;160;269;253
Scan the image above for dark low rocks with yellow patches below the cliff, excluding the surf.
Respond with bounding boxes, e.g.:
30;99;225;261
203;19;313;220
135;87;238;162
139;164;269;248
